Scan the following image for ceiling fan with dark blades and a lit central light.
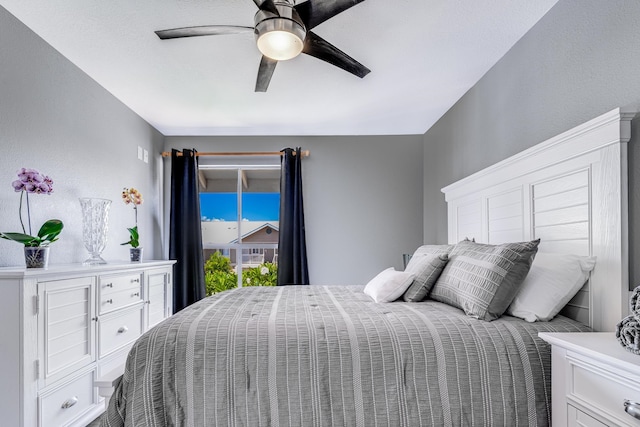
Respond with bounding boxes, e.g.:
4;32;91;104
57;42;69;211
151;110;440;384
155;0;371;92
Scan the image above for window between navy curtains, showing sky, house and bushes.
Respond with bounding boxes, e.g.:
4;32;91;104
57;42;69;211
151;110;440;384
199;164;280;295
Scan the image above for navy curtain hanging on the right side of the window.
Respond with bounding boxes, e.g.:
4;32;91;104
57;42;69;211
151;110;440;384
278;147;309;286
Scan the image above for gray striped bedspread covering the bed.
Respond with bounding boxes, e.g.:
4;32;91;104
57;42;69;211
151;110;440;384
102;286;587;427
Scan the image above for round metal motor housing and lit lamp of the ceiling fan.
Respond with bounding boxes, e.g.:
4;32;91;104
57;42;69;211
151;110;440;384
254;2;307;61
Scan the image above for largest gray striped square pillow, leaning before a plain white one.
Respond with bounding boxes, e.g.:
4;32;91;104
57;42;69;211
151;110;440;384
430;239;540;321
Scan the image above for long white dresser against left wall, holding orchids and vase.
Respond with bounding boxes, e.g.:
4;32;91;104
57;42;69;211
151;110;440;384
0;261;174;427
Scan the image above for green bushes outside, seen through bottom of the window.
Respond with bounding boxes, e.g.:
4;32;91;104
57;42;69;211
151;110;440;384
204;252;278;296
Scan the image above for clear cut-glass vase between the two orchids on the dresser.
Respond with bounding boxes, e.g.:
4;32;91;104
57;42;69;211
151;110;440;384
79;198;111;265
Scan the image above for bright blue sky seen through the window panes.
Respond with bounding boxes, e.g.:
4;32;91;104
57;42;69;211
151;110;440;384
200;193;280;221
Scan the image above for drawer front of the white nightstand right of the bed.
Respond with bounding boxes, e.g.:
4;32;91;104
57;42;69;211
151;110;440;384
568;356;640;426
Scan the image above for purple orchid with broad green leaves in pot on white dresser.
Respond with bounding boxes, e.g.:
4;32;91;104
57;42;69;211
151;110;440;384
0;168;64;268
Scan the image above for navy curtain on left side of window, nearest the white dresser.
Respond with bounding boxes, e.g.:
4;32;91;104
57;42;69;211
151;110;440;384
169;150;206;313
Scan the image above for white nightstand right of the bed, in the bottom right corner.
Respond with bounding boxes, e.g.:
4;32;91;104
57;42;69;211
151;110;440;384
539;332;640;427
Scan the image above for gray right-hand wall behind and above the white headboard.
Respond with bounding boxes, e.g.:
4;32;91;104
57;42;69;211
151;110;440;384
424;0;640;287
